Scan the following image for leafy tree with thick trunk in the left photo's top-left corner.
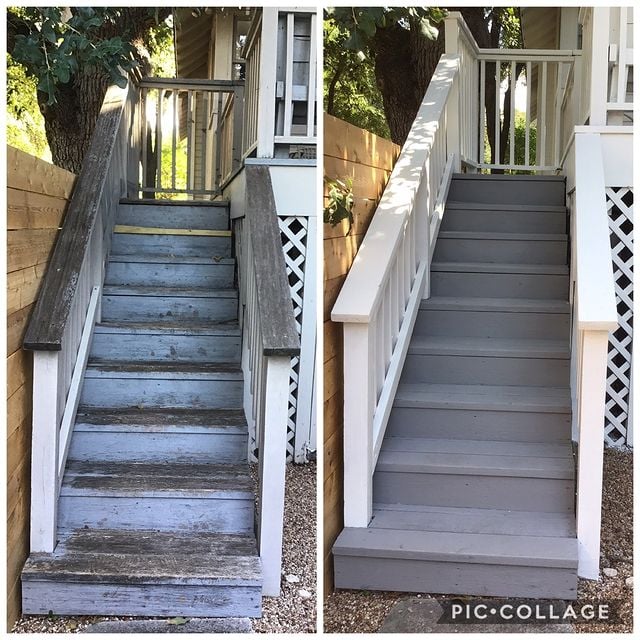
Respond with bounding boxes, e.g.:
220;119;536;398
7;7;171;172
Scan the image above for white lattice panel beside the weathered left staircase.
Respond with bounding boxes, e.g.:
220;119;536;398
278;216;312;460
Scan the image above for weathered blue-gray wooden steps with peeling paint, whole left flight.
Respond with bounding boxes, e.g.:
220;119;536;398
22;203;262;617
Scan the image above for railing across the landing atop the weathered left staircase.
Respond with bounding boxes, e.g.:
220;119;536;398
130;78;244;198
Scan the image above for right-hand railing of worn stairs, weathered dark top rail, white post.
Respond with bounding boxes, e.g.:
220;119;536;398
234;165;300;596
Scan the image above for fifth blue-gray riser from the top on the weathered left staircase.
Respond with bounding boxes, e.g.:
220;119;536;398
90;332;240;363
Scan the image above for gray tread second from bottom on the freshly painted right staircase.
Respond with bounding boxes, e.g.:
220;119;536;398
376;437;574;479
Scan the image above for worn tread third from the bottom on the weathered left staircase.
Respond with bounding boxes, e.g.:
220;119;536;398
75;407;247;433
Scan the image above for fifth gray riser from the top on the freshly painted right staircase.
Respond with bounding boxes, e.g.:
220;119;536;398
414;309;569;340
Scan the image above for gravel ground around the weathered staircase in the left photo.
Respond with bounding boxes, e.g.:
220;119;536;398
11;463;317;633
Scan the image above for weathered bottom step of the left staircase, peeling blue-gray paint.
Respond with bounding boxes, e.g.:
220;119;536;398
22;529;262;617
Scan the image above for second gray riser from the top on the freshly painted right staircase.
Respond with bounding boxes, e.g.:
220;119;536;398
440;208;567;233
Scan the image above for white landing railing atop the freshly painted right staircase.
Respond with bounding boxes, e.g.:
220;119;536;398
445;12;580;171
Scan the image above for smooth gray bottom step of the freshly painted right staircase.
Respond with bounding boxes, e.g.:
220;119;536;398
333;516;578;600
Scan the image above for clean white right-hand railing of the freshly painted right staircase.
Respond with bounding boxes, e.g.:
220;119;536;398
563;127;633;579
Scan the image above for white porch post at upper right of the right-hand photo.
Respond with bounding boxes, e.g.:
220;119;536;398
587;7;611;126
